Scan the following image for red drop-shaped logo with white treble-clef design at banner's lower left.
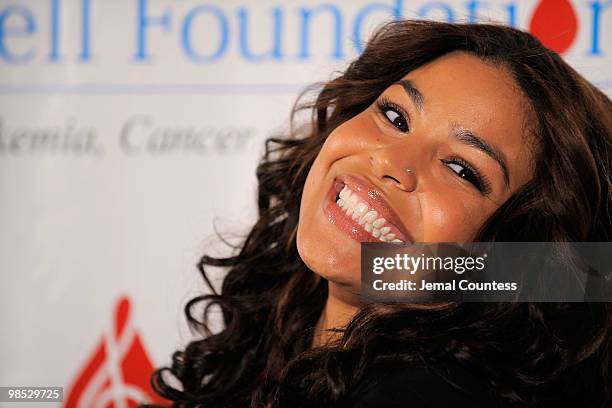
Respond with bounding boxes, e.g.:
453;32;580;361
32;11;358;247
64;297;167;408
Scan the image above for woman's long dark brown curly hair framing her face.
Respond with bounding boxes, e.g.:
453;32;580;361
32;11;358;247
151;20;612;408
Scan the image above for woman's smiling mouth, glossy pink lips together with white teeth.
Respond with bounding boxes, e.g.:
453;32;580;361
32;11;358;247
323;175;413;243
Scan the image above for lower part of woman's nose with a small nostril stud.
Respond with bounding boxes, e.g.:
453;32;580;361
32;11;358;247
370;150;418;192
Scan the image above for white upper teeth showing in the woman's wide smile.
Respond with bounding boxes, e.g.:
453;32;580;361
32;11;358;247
336;186;404;244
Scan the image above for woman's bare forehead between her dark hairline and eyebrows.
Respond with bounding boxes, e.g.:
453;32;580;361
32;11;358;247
395;52;533;189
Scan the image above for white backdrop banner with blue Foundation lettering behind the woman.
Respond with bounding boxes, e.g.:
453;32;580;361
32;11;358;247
0;0;612;407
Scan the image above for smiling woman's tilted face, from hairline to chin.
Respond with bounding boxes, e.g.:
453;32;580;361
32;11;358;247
297;52;533;293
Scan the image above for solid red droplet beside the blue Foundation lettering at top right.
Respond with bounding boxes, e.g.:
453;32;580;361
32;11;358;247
529;0;578;54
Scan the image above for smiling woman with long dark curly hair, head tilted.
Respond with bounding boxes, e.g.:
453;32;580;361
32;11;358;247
147;21;612;407
